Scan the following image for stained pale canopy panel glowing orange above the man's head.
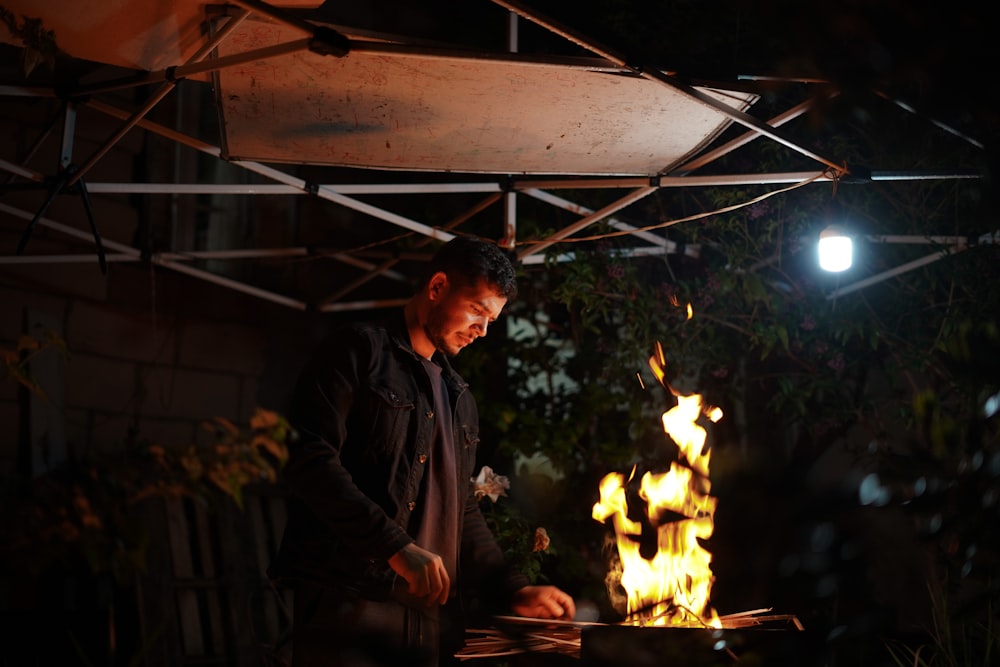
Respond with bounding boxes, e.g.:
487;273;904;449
216;20;756;176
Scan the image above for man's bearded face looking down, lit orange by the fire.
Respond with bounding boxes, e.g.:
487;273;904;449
424;274;507;356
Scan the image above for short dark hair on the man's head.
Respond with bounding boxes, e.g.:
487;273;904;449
424;236;517;301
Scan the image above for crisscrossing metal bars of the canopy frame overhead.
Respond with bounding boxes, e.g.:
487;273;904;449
0;0;980;312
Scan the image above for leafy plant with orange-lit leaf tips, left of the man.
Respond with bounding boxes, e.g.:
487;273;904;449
0;409;292;582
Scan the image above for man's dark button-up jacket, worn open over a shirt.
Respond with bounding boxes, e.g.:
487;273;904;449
271;312;528;605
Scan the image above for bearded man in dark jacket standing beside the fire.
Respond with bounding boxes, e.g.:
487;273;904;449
272;237;575;667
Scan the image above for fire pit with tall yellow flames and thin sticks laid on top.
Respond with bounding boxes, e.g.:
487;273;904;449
457;347;807;667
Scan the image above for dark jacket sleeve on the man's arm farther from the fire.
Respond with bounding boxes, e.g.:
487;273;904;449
283;329;413;560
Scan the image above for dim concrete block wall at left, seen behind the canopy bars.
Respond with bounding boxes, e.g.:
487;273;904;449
0;86;332;474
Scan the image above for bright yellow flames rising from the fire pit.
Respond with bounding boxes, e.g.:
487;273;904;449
593;349;722;628
